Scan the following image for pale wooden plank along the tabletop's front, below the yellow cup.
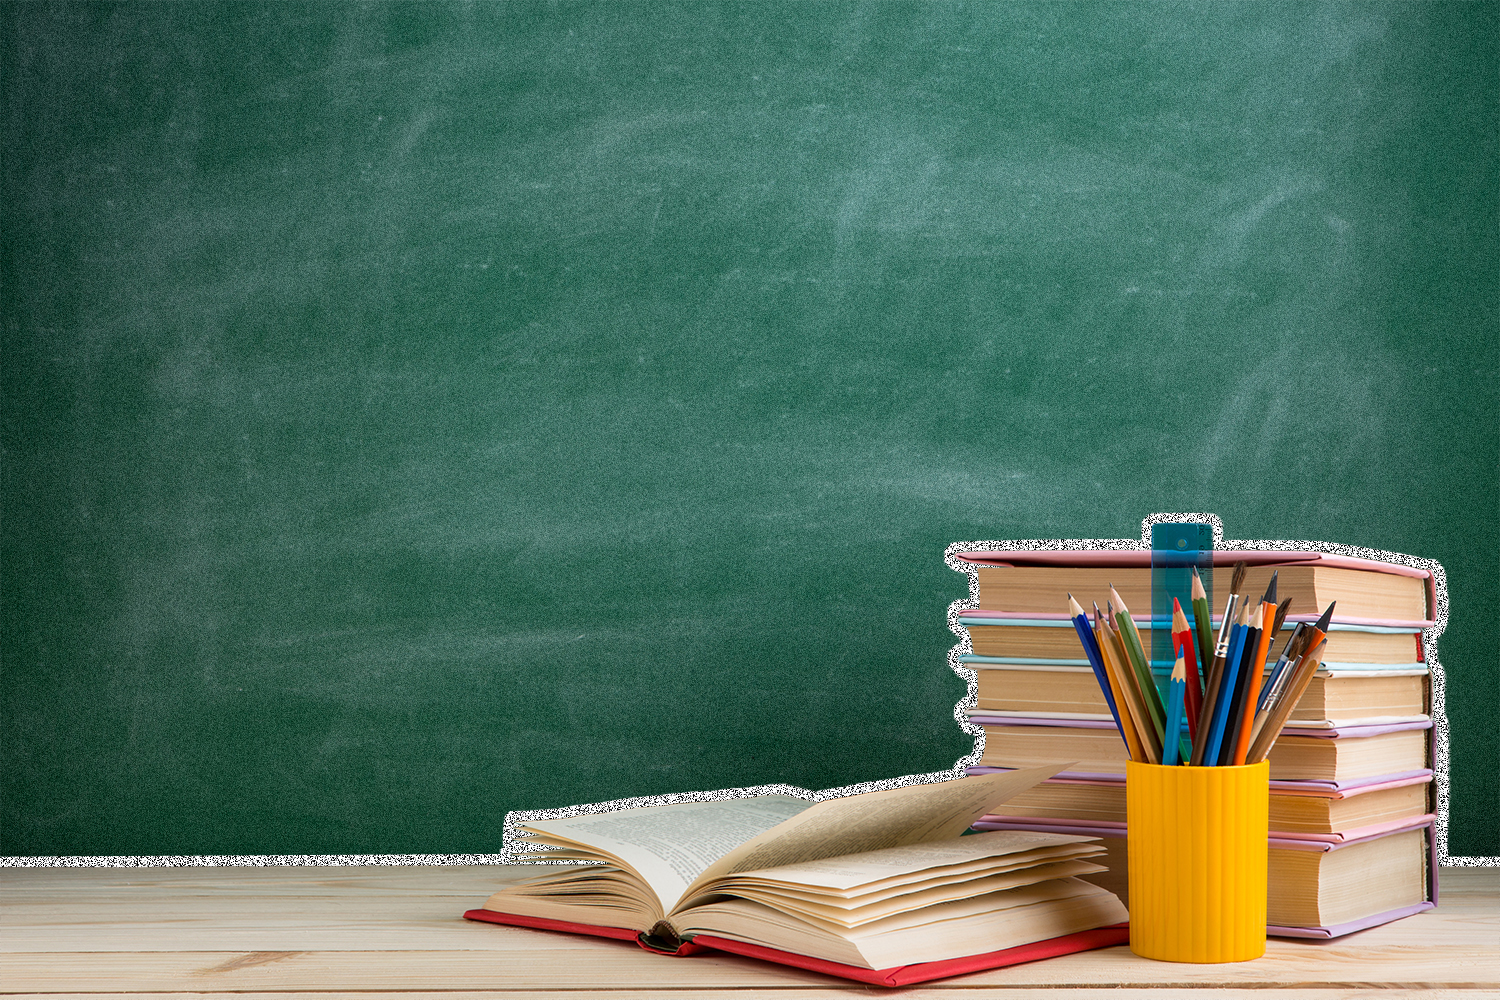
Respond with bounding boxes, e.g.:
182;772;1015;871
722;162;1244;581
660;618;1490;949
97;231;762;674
0;937;1500;993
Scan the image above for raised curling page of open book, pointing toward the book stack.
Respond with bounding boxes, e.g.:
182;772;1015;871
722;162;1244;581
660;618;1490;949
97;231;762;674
675;762;1073;913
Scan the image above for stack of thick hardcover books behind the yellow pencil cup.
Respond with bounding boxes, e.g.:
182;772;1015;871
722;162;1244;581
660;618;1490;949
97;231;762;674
959;550;1437;939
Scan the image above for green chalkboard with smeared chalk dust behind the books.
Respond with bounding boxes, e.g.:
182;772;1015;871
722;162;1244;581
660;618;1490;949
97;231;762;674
0;3;1500;855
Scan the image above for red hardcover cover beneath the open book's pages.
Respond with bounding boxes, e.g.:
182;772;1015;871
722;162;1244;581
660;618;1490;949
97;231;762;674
464;910;1130;987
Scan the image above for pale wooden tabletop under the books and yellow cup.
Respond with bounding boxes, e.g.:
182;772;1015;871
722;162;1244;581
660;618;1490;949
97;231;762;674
0;867;1500;1000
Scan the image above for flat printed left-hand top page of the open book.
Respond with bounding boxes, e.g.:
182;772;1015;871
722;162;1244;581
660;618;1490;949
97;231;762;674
522;795;810;918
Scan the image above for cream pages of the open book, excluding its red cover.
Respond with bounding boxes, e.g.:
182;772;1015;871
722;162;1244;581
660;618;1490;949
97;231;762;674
467;765;1128;975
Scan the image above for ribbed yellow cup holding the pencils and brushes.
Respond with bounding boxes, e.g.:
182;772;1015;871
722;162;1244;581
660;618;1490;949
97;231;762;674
1125;760;1271;963
